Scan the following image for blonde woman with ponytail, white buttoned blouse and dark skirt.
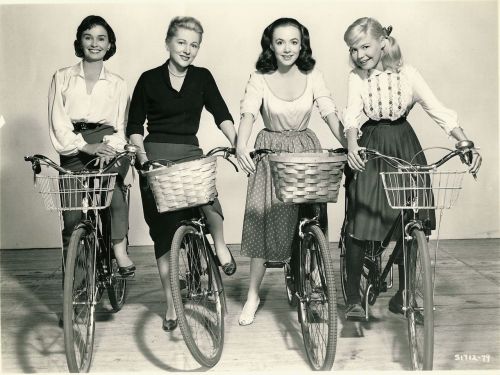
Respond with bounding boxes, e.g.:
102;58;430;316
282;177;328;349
343;17;481;318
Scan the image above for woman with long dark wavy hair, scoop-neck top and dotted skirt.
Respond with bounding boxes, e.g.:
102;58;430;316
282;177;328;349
236;18;344;325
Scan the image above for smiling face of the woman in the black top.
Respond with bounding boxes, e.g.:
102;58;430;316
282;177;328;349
166;28;201;70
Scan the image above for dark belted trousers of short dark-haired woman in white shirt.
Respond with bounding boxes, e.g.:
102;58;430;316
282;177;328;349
60;125;130;242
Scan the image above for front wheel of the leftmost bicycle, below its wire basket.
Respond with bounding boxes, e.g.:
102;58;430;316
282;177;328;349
63;228;97;372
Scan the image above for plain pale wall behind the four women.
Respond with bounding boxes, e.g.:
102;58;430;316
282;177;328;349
0;0;499;249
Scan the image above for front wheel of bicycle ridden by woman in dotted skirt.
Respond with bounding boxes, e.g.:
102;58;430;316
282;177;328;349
297;225;337;371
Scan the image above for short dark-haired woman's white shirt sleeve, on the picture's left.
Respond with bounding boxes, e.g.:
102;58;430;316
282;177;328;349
48;71;87;155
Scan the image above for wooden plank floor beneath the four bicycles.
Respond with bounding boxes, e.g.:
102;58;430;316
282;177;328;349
0;240;500;374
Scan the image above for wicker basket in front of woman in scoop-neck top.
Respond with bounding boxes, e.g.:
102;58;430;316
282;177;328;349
269;153;347;203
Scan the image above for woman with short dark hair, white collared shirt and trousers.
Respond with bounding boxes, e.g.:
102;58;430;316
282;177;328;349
49;16;135;277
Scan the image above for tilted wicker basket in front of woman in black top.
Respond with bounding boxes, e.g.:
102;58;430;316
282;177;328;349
144;156;217;212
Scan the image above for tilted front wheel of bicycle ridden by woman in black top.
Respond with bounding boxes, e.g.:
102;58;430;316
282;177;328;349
170;225;225;367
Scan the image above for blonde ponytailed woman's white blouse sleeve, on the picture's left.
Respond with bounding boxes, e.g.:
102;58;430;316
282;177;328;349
341;72;368;136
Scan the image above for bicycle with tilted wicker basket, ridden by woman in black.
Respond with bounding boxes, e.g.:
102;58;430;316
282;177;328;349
141;147;238;367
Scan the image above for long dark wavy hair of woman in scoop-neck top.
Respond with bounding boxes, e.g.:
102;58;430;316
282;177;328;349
255;18;316;73
